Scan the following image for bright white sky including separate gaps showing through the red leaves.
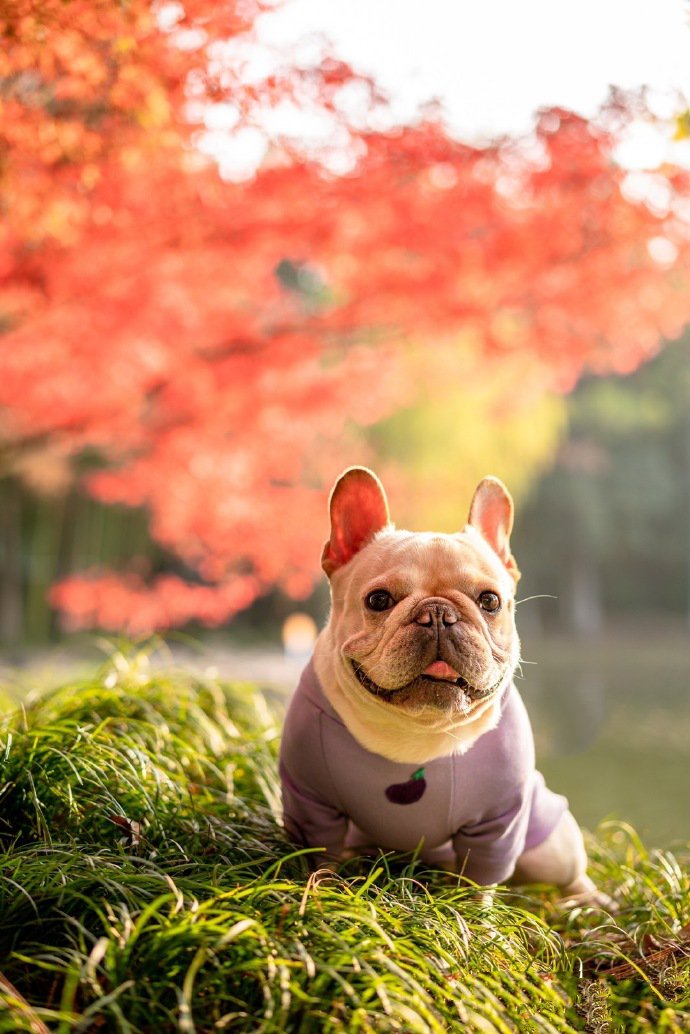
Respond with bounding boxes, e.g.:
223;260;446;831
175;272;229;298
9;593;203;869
198;0;690;178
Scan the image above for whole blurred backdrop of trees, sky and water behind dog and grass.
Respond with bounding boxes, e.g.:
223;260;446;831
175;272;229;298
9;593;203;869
0;0;690;845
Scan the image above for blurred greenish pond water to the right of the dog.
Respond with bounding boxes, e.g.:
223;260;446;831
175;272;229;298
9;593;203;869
517;627;690;847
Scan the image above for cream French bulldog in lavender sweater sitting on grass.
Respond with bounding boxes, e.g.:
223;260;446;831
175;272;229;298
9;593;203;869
280;467;604;904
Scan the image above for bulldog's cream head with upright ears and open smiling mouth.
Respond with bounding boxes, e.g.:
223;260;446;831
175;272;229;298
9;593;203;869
317;467;519;761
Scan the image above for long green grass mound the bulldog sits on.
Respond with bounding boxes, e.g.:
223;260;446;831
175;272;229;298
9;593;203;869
0;650;690;1034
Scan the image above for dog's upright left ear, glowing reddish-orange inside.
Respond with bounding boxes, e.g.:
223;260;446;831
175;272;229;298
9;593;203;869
321;466;390;578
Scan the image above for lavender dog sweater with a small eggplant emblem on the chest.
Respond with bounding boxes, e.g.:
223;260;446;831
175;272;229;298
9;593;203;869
280;663;568;884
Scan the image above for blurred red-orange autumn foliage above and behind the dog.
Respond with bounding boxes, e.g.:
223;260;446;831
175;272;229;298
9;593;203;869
0;0;688;632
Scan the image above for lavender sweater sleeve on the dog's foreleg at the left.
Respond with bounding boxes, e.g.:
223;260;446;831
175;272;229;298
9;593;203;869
280;696;348;861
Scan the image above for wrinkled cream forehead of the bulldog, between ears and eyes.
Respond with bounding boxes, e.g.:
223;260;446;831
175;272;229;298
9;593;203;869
342;527;514;597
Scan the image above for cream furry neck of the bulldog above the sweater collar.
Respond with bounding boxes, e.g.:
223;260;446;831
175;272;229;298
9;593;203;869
313;628;512;764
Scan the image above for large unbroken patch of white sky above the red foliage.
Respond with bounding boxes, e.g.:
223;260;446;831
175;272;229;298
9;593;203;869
261;0;690;136
